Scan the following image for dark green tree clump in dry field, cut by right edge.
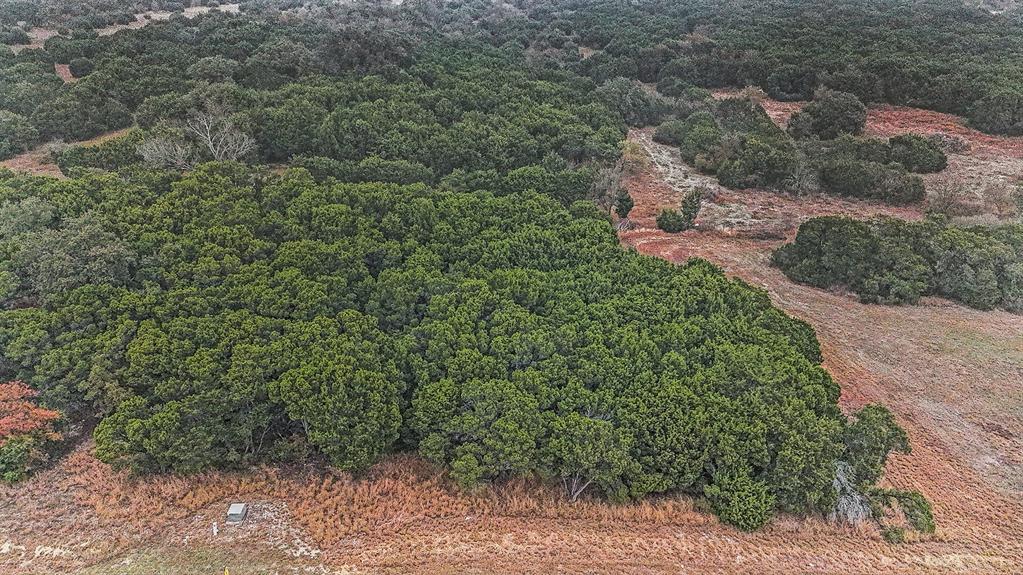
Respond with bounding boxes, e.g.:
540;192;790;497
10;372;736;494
773;217;1023;312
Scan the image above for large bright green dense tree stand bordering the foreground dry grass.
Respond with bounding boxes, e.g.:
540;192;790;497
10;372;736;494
0;163;904;528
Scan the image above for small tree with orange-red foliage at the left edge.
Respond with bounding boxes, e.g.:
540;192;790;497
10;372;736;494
0;382;60;482
